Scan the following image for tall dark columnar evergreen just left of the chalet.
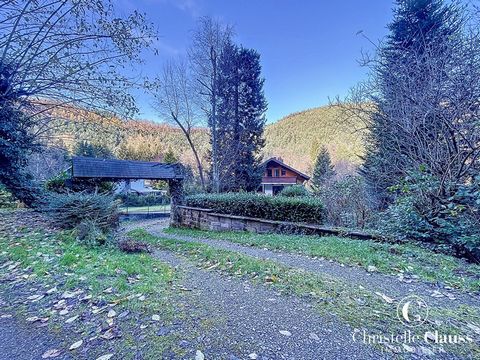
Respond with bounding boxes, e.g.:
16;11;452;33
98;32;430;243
218;43;267;191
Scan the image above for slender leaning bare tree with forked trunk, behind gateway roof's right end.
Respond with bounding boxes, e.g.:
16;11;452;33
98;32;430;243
154;60;205;189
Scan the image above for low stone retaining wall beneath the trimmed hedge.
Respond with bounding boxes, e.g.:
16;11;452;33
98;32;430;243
172;206;375;239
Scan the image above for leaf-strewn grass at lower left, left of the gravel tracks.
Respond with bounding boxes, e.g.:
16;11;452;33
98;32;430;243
0;221;191;359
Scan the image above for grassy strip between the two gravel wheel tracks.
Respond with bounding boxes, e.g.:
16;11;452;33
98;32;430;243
129;229;480;358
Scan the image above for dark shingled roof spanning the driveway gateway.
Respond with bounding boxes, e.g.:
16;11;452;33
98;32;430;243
72;157;183;180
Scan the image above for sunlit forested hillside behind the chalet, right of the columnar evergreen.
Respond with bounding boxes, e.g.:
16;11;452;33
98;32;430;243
264;106;363;174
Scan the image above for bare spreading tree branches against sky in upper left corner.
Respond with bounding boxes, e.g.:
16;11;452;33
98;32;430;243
0;0;156;124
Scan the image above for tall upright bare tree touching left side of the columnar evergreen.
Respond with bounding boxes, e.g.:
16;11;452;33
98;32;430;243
189;17;233;192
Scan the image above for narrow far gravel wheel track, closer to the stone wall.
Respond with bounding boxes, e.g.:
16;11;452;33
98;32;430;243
137;221;480;308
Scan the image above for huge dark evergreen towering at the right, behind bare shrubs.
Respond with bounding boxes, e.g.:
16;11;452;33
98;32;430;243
362;0;462;204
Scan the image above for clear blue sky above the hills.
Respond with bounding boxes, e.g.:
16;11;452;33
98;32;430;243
119;0;393;123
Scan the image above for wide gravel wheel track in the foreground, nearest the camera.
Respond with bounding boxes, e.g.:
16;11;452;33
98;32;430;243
153;251;391;360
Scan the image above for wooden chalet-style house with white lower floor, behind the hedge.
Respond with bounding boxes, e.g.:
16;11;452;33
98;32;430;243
261;157;310;195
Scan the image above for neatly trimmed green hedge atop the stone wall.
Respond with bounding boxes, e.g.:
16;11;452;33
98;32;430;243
186;193;324;224
